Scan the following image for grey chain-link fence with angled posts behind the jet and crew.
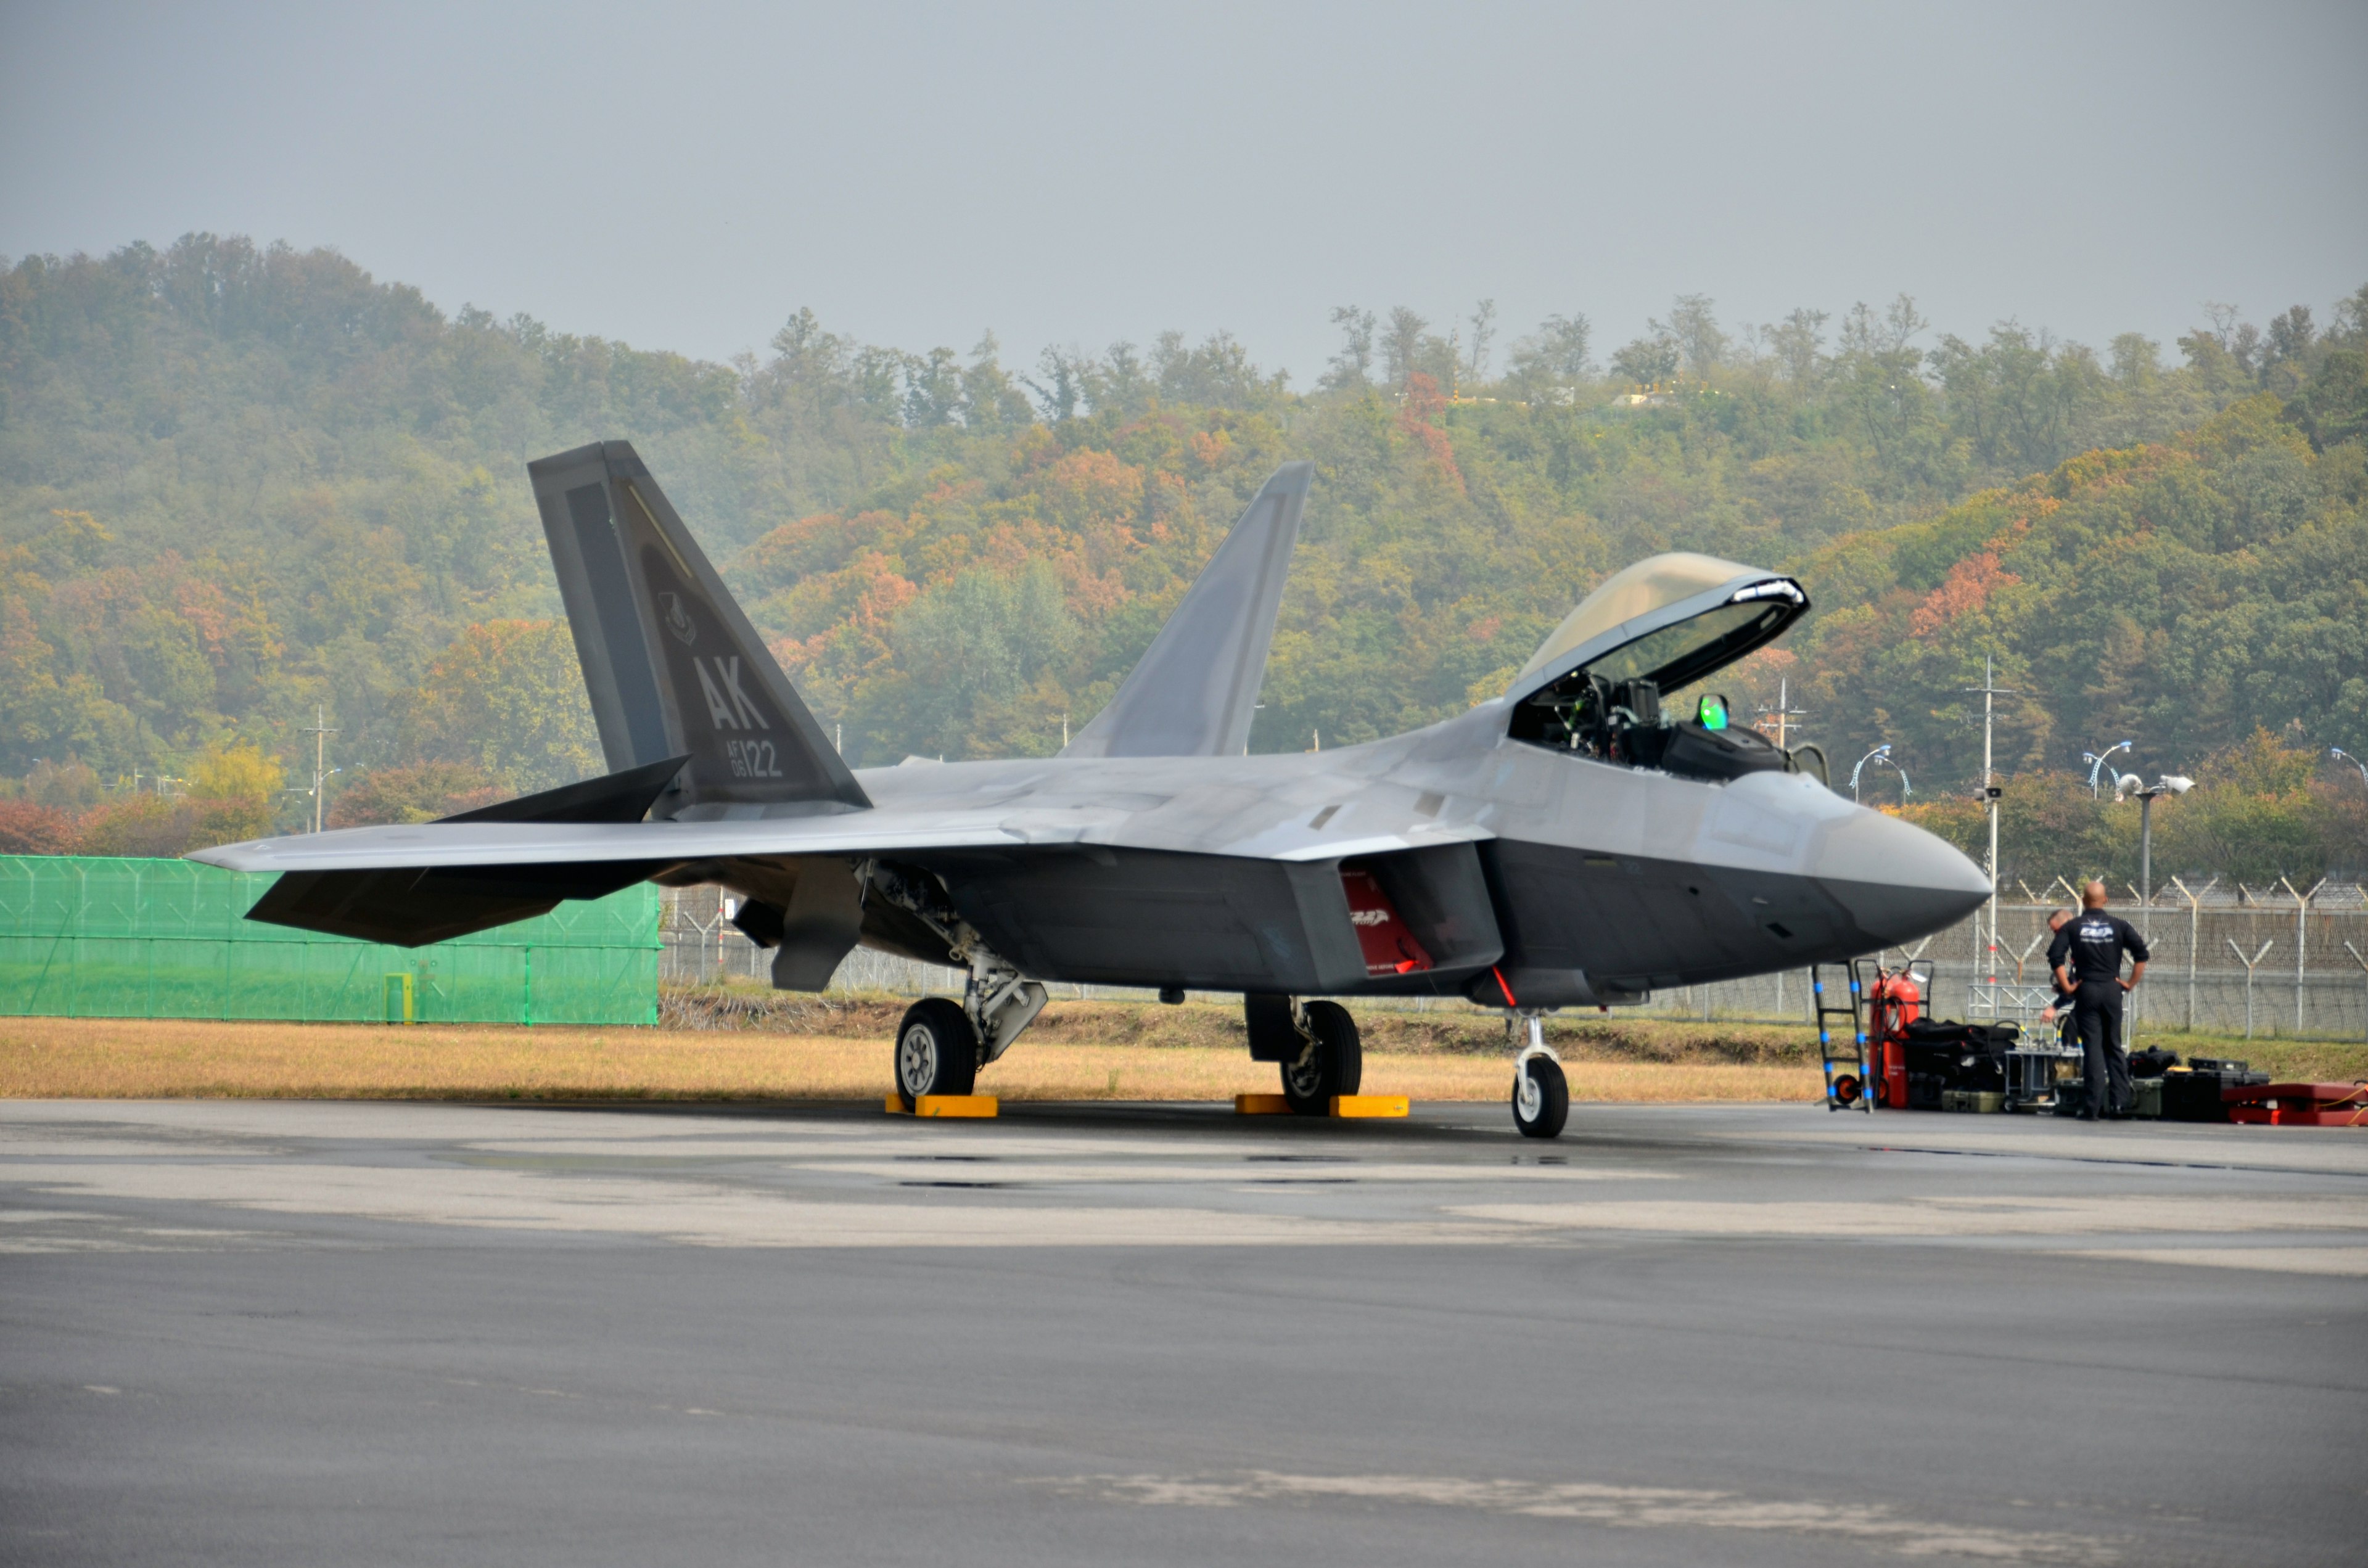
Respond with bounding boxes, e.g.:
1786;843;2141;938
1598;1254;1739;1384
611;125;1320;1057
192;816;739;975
660;879;2368;1040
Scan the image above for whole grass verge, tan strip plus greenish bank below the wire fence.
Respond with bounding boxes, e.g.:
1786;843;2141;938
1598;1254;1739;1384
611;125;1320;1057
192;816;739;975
0;985;2368;1101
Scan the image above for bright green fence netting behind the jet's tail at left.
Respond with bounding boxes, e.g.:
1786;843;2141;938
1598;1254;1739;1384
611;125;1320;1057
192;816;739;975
0;855;660;1023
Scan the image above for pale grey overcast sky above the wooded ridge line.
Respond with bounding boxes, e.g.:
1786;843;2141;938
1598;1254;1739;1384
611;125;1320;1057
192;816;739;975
0;0;2368;386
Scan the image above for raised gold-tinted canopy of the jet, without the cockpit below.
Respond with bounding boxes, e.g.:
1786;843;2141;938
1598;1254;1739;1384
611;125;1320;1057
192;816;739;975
1506;549;1809;701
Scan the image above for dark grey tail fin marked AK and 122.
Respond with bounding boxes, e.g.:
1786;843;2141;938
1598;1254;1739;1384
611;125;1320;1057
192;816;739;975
525;440;871;817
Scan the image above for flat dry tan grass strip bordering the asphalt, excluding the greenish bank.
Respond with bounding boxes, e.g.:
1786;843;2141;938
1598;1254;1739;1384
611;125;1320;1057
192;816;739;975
0;1009;1819;1101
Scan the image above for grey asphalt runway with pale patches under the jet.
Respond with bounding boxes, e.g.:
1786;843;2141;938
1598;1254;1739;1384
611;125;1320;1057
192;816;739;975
0;1101;2368;1568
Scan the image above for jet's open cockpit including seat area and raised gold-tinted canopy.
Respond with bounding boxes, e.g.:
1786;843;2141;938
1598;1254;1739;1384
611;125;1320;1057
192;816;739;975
1506;552;1823;779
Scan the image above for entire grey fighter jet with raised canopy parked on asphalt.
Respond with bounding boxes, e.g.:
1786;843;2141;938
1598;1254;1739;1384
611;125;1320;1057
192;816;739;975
197;440;1989;1137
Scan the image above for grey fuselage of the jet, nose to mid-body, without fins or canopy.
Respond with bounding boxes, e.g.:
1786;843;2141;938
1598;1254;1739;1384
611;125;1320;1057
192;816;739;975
824;701;1989;1007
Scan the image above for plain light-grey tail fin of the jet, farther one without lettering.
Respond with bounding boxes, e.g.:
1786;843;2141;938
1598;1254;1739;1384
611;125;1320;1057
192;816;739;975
1061;462;1317;758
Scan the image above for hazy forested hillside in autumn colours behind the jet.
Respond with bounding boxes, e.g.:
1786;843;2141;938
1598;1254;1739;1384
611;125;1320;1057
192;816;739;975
0;237;2368;871
